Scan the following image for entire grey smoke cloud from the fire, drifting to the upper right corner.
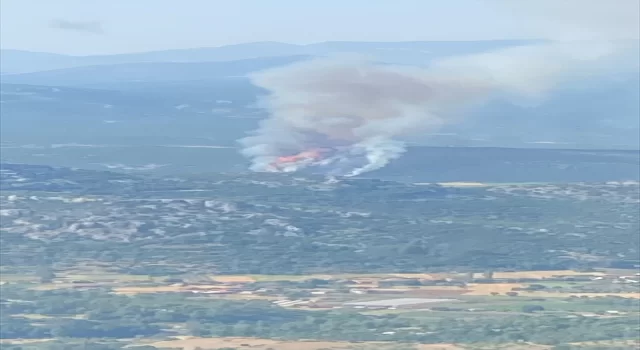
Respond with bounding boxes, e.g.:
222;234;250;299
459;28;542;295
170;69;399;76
240;0;639;176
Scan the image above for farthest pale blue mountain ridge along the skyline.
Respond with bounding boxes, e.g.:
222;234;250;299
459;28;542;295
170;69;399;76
0;40;539;74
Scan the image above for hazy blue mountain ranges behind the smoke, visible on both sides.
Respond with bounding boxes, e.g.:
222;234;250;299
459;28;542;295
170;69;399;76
0;40;640;149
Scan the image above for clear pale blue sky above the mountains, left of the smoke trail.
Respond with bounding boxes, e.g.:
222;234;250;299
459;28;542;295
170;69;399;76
0;0;532;55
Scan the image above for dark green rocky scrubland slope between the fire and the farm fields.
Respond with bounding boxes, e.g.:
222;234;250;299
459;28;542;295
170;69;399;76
0;164;640;274
